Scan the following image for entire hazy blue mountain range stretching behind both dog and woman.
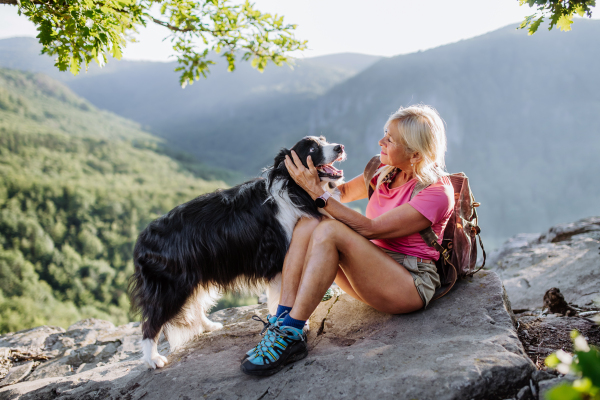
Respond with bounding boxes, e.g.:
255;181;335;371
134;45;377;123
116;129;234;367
0;20;600;247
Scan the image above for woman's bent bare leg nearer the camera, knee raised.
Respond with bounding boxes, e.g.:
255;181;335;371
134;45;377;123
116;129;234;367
290;220;423;320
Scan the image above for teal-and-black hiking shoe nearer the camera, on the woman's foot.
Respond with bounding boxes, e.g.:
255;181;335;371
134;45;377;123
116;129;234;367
240;325;308;376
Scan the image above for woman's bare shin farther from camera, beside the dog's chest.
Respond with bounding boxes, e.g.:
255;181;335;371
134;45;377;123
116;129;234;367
279;218;320;307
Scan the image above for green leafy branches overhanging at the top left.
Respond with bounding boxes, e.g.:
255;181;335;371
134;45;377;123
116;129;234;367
0;0;306;87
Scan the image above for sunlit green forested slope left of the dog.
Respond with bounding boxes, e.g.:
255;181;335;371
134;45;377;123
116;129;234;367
0;69;227;333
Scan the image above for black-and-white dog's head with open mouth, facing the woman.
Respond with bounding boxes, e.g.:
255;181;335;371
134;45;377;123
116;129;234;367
273;136;346;182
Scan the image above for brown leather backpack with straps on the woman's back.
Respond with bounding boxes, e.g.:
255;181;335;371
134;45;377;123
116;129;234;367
363;155;486;300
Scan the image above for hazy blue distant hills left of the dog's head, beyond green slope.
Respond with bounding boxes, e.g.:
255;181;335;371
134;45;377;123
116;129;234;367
0;38;381;176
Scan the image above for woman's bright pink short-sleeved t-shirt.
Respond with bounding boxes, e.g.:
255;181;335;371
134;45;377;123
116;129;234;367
366;176;454;260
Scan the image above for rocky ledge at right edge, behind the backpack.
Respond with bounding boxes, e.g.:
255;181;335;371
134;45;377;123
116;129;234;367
489;217;600;390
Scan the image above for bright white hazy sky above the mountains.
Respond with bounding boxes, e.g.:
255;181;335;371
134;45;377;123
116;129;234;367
0;0;596;61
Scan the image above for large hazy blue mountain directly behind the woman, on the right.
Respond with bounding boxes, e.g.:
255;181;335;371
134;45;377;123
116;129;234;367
310;20;600;245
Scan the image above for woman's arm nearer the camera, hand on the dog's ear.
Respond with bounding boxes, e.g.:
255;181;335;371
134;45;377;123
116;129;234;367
285;151;431;239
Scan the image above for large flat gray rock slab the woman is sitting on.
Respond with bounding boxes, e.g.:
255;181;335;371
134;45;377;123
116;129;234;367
0;272;535;400
